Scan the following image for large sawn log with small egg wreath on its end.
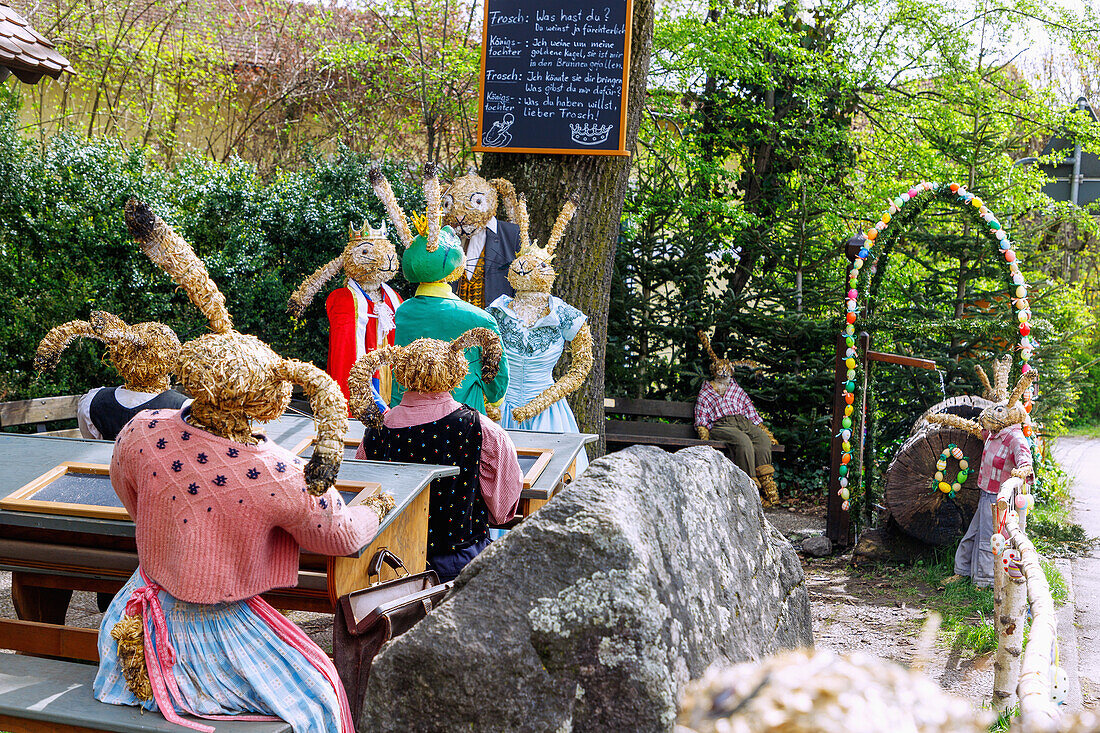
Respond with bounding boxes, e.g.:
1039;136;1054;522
883;422;985;545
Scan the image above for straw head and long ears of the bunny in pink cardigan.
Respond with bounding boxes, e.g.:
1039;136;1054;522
125;199;348;495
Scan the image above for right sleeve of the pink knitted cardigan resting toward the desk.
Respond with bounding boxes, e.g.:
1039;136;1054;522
279;482;378;556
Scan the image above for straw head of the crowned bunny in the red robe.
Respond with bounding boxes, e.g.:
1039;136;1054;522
287;221;400;318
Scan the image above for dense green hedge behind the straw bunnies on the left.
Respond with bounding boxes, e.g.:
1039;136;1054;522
0;112;424;400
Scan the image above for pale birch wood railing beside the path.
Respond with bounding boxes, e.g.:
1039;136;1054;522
993;477;1059;733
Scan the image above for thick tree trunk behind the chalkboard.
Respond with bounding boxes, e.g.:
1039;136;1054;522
479;0;655;455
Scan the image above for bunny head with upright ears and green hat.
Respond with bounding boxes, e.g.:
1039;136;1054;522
370;163;466;284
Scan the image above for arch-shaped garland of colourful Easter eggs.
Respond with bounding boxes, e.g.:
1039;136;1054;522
835;180;1035;512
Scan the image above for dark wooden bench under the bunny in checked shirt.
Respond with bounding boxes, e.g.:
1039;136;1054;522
604;397;783;453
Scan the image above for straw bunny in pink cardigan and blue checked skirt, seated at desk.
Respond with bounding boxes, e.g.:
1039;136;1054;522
92;199;393;733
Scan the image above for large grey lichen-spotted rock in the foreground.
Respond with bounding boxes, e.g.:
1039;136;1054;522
360;446;813;732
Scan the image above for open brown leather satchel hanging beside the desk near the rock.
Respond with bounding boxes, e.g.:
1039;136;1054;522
332;548;454;720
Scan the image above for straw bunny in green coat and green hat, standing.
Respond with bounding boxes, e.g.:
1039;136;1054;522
370;163;508;419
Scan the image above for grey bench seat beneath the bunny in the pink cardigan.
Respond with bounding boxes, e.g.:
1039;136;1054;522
0;653;292;733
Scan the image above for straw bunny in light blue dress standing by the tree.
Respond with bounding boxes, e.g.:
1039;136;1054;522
488;191;592;474
